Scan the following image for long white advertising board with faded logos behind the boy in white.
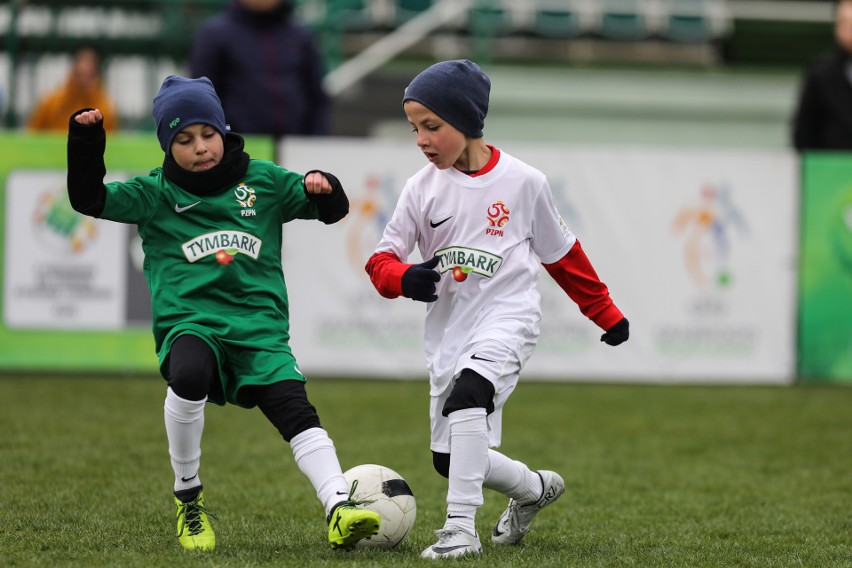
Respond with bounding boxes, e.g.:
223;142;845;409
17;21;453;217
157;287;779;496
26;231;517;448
278;138;798;383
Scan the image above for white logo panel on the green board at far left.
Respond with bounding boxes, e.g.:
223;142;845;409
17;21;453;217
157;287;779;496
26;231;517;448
3;170;127;329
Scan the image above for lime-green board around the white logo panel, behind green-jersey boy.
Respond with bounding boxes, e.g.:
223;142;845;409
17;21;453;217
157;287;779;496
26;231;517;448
0;133;274;373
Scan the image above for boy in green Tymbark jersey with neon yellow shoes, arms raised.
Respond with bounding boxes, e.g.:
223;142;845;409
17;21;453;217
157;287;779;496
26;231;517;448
68;76;379;550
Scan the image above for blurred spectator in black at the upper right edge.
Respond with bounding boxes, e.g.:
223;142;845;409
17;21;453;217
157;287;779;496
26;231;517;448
793;0;852;150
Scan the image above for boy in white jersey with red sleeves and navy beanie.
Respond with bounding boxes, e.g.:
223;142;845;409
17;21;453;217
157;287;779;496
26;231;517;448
366;60;629;558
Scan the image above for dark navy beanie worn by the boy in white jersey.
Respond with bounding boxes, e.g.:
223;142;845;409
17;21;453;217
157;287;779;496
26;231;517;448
402;59;491;138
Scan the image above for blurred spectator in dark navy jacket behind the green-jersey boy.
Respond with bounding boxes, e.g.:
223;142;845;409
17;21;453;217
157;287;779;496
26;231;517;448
189;0;329;136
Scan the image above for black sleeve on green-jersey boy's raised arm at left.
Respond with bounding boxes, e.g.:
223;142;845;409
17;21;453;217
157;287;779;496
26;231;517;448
68;109;106;217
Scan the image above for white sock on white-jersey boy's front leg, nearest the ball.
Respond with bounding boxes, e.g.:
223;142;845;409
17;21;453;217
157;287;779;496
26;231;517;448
444;408;488;534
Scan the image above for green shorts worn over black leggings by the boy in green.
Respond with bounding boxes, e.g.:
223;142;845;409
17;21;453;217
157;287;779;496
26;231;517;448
159;325;305;408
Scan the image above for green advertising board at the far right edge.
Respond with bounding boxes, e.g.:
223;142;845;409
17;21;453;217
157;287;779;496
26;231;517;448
798;154;852;383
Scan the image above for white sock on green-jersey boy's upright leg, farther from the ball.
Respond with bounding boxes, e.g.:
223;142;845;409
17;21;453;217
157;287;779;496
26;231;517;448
163;387;207;491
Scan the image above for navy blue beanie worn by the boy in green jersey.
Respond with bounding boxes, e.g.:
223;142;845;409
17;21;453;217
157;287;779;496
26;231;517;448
154;75;228;154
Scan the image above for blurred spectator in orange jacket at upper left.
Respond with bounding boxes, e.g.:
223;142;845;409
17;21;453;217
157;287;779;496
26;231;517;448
27;47;118;132
